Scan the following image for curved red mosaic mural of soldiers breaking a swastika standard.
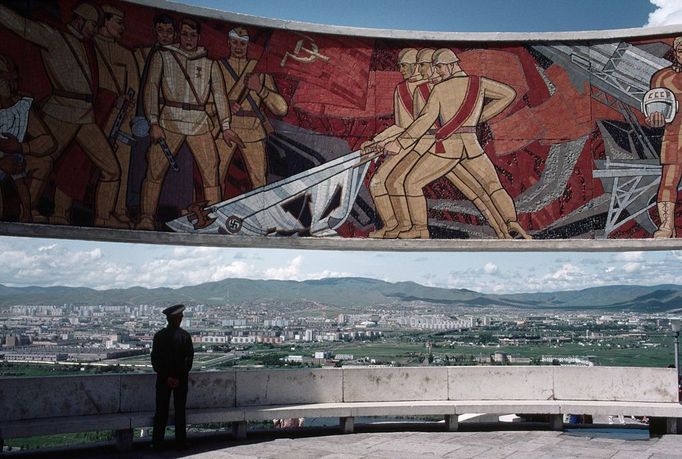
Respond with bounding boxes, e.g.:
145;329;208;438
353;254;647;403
0;0;682;243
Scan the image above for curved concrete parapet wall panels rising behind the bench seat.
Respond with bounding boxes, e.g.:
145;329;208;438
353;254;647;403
0;367;679;422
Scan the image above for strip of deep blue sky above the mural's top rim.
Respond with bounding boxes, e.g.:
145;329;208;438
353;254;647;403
186;0;660;32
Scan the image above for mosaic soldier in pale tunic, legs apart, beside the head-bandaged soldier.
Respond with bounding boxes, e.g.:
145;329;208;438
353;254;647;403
137;18;242;230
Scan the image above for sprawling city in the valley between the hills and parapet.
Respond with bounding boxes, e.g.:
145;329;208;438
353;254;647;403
0;288;674;377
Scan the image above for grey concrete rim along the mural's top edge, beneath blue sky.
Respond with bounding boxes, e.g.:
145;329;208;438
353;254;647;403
133;0;682;42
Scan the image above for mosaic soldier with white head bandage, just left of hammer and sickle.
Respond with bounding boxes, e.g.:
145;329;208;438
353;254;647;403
218;27;289;188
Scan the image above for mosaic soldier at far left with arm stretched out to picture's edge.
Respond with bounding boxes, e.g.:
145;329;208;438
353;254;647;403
0;3;121;227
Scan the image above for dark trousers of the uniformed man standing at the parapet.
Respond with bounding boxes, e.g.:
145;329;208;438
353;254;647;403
152;375;188;445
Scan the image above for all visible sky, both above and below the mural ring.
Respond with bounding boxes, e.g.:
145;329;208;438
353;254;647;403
0;0;682;293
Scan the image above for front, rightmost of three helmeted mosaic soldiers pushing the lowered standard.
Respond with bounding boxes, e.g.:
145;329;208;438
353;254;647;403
385;48;528;239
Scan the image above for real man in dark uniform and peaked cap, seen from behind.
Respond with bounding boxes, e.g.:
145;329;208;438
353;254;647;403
152;304;194;449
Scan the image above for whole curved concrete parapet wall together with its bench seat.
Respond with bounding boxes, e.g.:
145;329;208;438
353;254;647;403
0;366;682;438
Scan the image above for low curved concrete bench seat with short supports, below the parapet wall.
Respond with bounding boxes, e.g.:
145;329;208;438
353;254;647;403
0;400;682;438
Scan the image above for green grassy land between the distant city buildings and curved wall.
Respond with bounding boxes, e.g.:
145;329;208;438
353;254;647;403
0;334;674;377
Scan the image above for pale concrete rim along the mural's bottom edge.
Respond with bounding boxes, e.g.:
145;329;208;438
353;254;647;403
0;222;682;252
